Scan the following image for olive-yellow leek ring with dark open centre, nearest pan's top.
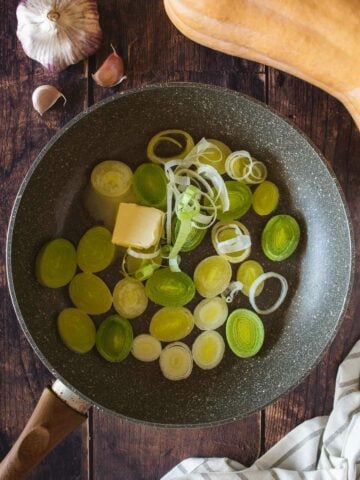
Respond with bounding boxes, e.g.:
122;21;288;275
146;129;194;163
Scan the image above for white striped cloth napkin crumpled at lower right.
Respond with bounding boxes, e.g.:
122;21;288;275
161;340;360;480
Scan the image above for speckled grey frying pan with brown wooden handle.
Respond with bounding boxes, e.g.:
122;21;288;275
0;83;353;479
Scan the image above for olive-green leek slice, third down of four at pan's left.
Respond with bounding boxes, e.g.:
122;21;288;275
69;273;112;315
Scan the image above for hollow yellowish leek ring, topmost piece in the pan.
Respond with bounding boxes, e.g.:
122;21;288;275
146;129;194;163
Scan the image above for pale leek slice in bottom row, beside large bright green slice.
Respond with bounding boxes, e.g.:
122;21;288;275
192;330;225;370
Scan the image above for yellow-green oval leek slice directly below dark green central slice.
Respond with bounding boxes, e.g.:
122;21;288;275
149;307;194;342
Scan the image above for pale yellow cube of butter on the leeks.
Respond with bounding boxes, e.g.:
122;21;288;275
112;203;165;249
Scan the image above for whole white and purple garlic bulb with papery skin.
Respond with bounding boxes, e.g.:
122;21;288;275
16;0;102;71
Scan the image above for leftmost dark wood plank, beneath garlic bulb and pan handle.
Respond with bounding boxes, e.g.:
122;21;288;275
0;0;88;480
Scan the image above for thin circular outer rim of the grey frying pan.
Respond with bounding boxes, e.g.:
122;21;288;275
5;82;355;428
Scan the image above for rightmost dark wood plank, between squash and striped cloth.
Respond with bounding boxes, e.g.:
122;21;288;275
263;69;360;450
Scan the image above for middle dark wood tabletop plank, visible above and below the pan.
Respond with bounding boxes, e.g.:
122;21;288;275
92;0;265;480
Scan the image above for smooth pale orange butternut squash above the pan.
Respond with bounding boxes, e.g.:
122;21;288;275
164;0;360;128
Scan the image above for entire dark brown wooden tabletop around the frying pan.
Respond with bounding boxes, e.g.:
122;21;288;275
0;0;360;480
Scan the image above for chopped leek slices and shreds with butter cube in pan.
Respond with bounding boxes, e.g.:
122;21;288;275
35;129;300;381
